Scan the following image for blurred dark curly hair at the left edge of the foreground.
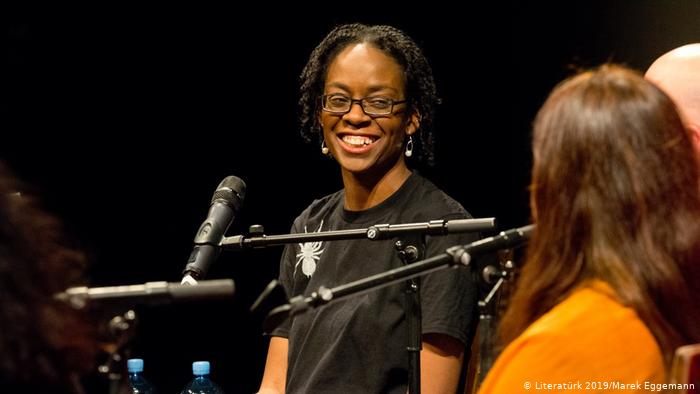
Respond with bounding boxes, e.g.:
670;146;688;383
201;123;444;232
0;163;97;393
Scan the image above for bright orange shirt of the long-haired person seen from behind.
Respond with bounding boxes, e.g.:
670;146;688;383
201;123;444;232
479;281;665;394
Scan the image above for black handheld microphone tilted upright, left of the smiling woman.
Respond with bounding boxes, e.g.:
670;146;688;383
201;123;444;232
181;176;245;285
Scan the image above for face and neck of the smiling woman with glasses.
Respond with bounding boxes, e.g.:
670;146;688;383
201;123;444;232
321;43;420;188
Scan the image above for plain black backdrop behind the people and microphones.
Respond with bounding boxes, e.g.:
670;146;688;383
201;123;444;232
5;0;700;393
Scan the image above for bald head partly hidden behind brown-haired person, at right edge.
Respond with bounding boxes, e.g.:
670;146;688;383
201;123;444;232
645;43;700;130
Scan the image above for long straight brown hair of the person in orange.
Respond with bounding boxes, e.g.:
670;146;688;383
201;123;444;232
500;65;700;363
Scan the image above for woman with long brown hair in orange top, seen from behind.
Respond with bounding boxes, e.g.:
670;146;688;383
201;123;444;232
480;65;700;394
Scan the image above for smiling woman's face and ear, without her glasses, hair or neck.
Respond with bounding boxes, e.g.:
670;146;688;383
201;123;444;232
320;44;418;175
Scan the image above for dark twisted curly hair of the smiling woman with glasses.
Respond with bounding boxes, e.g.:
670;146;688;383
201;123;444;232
299;23;440;165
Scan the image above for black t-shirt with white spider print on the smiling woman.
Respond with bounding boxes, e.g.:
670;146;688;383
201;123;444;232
272;173;477;394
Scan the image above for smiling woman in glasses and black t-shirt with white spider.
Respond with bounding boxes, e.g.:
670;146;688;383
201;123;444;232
260;24;476;394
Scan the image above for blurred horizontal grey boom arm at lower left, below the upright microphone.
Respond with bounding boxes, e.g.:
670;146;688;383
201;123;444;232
54;279;235;309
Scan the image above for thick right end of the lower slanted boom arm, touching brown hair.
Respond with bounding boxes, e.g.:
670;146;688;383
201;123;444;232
447;224;535;265
